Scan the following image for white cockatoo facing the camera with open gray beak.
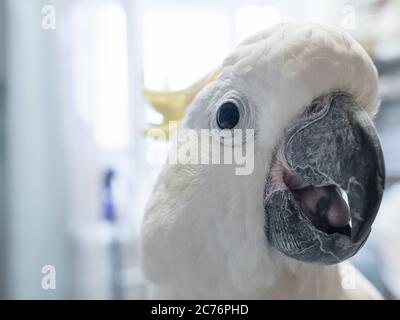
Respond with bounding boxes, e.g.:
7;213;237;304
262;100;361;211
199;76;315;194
141;23;385;299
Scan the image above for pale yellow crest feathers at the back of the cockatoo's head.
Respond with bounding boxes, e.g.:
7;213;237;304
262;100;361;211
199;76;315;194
143;69;220;139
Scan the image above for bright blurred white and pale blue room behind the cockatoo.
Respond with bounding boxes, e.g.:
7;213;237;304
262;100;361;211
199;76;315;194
0;0;400;299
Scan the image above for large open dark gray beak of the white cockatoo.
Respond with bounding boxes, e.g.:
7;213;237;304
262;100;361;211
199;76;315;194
264;93;385;264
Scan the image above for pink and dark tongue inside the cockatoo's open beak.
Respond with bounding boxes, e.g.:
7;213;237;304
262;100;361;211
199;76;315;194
294;186;350;228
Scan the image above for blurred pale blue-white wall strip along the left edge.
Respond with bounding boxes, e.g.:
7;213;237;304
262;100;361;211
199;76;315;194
6;0;71;299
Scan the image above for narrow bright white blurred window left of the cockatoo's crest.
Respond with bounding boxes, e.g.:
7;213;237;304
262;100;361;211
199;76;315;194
71;1;129;151
